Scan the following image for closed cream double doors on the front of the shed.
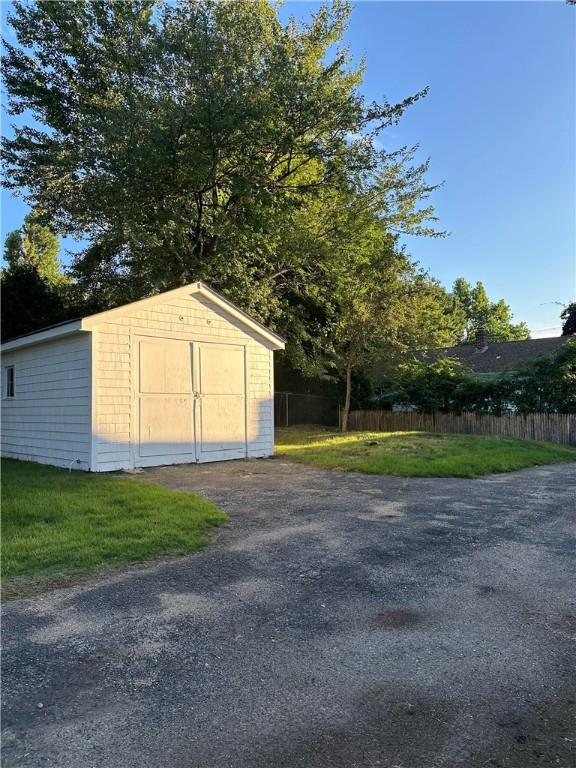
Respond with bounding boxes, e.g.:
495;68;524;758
134;337;246;467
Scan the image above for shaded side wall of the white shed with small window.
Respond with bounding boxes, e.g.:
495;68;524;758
2;333;91;469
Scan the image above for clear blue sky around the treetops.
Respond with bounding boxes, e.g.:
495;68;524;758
2;0;576;336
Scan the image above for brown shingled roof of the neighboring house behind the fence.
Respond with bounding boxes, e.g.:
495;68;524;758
416;336;574;373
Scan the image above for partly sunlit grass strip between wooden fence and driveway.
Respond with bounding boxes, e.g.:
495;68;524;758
276;426;576;477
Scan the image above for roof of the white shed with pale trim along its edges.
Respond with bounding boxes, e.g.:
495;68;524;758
2;282;286;352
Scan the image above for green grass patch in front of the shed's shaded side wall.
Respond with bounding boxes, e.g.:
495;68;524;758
2;459;227;596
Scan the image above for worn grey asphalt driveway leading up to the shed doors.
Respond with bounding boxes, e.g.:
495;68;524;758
2;459;576;768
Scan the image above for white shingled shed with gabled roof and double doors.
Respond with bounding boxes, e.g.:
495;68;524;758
2;283;284;472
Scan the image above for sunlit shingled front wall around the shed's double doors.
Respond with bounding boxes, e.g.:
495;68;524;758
92;295;274;472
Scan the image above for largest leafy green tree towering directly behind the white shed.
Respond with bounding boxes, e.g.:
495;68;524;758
3;0;446;369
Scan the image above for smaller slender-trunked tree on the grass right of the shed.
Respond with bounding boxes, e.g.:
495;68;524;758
308;167;444;431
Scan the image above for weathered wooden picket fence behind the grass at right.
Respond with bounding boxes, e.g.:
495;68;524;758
348;411;576;445
